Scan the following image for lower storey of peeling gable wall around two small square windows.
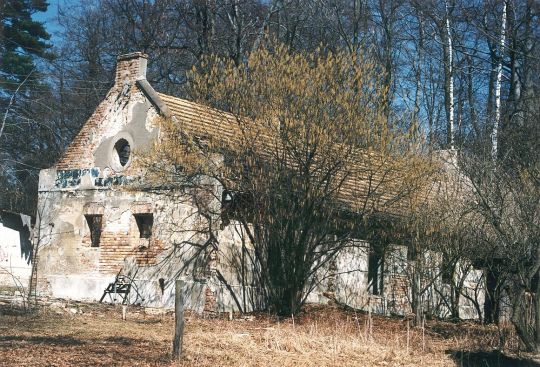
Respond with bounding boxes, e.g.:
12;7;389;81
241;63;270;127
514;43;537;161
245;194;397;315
38;184;256;311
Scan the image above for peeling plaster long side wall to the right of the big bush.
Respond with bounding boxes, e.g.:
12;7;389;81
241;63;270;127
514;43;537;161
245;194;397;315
308;240;485;319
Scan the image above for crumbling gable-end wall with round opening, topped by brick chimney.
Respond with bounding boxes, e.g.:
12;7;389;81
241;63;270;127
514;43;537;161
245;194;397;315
36;53;209;308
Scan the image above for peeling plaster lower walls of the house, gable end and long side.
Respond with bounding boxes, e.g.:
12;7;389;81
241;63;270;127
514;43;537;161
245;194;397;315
38;164;483;318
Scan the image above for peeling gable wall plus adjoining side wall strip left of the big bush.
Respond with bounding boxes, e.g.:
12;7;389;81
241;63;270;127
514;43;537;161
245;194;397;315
35;54;253;311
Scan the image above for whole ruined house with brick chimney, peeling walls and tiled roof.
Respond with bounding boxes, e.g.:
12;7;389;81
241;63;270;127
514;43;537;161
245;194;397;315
34;53;483;317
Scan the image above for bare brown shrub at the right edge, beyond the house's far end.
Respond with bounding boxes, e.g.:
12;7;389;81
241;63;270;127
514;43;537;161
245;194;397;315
460;153;540;352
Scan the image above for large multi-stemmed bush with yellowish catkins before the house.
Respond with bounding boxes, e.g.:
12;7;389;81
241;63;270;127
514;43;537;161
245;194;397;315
140;46;425;315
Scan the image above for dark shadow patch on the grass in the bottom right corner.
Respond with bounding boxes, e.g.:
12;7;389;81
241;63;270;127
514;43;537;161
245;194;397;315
446;350;540;367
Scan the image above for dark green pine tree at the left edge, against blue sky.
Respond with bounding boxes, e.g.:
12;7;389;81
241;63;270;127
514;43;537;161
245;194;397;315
0;0;52;214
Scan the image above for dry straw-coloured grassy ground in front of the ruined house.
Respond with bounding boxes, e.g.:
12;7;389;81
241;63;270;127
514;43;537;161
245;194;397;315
0;302;540;367
